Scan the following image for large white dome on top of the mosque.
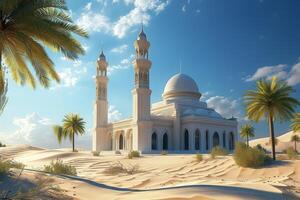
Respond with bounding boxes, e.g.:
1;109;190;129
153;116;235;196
163;73;201;100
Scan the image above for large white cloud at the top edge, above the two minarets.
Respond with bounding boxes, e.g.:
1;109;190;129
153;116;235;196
77;0;169;38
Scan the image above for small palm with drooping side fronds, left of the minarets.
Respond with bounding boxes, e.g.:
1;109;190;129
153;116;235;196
53;113;85;152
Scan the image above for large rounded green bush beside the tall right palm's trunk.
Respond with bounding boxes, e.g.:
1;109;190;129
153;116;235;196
233;142;271;168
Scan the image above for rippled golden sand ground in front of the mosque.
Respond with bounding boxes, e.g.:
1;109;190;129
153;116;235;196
0;146;300;200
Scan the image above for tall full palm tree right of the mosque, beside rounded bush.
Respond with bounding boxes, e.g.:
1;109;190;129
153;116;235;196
244;77;299;160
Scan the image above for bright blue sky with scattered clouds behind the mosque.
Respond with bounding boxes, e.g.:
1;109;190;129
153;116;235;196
0;0;300;148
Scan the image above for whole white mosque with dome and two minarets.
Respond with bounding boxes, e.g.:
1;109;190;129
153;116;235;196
93;29;238;153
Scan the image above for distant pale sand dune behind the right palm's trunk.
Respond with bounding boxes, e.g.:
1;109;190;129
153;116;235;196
249;131;300;152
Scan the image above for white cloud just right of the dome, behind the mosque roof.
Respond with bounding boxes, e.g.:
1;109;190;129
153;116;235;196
206;96;241;118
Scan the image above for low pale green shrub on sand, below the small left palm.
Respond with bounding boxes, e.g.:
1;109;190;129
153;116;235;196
44;159;77;176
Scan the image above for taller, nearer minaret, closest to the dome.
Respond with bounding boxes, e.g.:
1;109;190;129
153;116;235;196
132;28;152;151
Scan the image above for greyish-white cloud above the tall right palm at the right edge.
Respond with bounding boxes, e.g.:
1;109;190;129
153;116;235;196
244;62;300;86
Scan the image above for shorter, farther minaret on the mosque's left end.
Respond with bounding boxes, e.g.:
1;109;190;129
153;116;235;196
93;51;110;152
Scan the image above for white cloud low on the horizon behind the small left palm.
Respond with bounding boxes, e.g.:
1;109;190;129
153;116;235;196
0;113;91;149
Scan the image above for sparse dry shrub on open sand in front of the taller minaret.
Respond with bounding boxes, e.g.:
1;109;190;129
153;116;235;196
104;162;140;175
